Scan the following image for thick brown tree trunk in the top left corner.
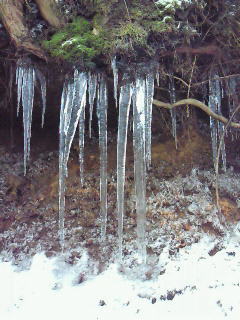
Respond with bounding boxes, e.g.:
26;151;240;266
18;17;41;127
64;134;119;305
0;0;47;60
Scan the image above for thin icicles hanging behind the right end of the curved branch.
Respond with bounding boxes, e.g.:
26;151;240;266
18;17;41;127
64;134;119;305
209;74;226;171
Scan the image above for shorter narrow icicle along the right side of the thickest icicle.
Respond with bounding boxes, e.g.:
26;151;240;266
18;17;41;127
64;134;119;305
145;72;154;169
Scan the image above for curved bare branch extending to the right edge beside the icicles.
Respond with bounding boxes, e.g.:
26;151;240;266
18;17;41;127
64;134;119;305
153;98;240;129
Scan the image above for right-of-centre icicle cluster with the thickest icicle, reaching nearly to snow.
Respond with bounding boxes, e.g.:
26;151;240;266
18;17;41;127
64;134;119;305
117;69;155;262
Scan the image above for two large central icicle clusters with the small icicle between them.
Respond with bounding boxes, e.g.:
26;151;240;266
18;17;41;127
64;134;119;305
59;62;154;260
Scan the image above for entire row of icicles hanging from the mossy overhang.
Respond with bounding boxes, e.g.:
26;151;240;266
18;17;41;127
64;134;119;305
16;59;239;262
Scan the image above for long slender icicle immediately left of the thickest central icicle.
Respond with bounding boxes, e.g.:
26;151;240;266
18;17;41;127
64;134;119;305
117;75;132;261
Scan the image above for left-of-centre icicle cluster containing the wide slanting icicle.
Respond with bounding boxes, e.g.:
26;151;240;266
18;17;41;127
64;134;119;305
59;69;108;248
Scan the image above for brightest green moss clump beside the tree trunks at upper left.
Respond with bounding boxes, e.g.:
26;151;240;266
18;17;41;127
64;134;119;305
42;18;106;65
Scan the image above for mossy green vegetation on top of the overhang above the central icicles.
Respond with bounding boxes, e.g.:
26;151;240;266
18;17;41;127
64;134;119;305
43;0;200;65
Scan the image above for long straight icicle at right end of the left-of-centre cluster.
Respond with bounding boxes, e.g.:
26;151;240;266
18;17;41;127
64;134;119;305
97;76;108;239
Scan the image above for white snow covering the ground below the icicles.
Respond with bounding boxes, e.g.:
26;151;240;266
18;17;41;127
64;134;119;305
0;227;240;320
